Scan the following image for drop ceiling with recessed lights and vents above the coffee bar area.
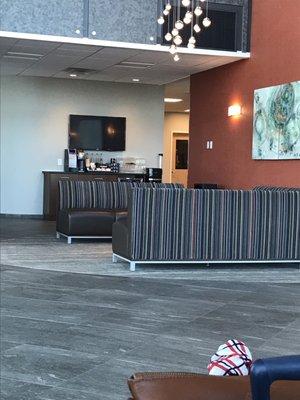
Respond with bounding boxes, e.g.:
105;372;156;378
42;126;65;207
0;34;248;85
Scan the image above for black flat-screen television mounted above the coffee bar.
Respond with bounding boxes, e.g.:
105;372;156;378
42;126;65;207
69;115;126;151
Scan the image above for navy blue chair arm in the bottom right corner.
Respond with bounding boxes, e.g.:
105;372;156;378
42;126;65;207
250;355;300;400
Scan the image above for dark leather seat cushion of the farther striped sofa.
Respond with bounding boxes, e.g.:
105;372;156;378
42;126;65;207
57;208;116;236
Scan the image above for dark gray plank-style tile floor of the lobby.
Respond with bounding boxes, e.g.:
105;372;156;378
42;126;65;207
1;220;300;400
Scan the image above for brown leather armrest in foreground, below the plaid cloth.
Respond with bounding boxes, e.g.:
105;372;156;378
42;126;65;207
128;373;251;400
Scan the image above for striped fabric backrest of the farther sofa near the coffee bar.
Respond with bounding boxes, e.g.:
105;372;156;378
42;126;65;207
59;180;182;210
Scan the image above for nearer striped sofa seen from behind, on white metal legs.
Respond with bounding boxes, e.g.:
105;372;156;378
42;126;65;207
113;188;300;270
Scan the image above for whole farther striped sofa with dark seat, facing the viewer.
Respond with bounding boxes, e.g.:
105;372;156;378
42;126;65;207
56;180;181;244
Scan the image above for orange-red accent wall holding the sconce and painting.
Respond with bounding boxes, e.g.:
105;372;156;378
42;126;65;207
189;0;300;189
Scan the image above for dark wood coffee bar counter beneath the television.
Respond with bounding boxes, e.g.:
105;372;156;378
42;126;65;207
43;171;145;221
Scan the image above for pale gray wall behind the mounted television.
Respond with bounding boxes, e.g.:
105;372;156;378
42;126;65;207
1;77;164;214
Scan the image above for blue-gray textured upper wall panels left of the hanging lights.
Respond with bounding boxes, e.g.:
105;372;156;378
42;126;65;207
0;0;157;43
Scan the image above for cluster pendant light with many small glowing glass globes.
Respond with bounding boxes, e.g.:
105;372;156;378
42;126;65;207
157;0;212;61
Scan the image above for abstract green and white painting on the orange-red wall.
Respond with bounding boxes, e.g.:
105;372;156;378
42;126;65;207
252;81;300;160
